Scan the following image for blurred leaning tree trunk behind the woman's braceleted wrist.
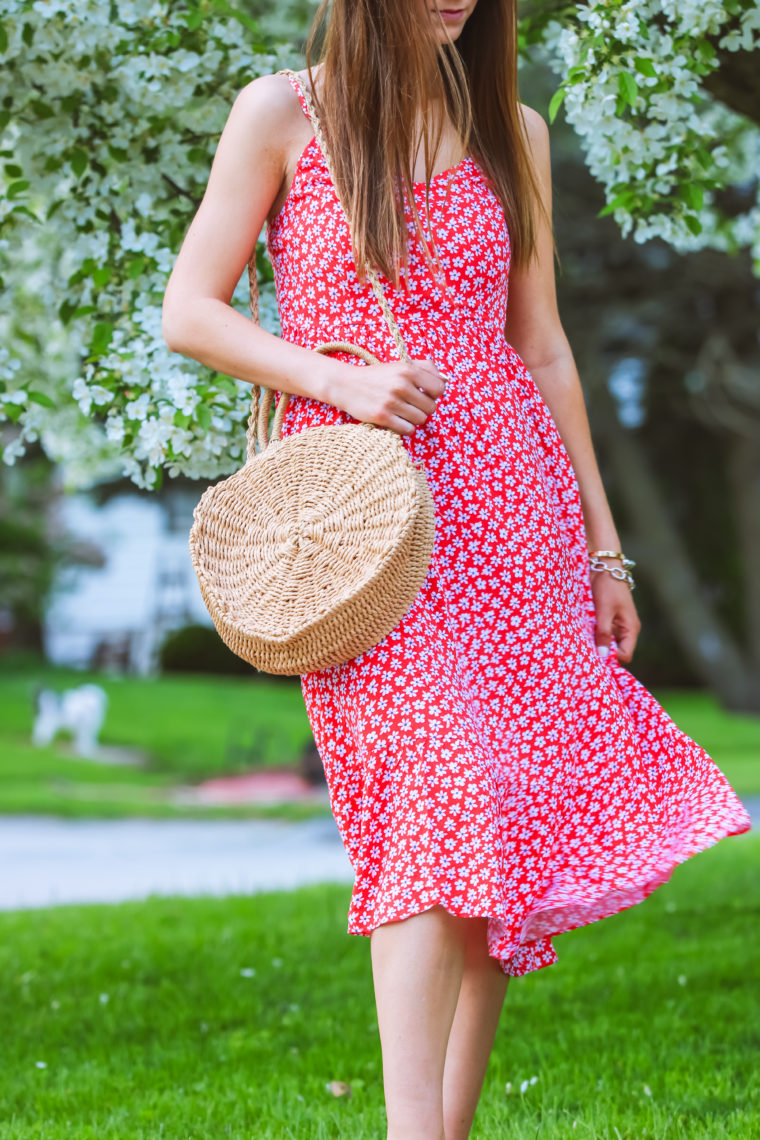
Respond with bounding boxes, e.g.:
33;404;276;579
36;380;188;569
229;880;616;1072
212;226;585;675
594;385;760;713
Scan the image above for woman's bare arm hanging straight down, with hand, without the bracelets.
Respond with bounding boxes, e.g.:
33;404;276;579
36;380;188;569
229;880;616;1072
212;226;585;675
506;107;640;661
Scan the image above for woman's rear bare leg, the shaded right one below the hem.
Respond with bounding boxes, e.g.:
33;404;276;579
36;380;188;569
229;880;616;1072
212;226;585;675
443;919;508;1140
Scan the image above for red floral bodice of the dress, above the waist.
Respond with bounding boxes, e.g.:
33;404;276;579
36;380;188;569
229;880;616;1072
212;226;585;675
268;131;509;368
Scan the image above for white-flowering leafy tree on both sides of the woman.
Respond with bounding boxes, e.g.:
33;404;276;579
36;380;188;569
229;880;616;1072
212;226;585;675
0;0;760;487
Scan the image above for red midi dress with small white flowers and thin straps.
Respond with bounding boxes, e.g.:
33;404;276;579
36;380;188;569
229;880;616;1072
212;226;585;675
268;80;750;975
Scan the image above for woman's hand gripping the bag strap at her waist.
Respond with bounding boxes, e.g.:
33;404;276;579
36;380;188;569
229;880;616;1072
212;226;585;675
327;359;446;435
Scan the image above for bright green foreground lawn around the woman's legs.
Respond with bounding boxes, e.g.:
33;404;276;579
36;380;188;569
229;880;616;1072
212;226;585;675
0;834;760;1140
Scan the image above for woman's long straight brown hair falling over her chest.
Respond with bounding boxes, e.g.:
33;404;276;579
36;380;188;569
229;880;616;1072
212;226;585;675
307;0;540;284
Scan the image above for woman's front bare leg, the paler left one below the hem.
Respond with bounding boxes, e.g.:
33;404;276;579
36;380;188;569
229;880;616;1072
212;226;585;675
371;906;473;1140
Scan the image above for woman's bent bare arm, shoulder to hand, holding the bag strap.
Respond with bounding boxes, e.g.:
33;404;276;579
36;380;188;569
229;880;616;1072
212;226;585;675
163;75;443;434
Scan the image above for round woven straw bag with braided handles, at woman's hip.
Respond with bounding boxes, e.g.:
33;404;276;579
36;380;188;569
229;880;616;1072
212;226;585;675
190;68;434;674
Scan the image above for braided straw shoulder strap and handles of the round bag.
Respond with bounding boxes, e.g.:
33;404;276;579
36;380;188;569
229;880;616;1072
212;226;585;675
246;68;411;459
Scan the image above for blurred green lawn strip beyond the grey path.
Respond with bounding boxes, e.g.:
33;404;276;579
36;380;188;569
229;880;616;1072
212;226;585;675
0;659;760;817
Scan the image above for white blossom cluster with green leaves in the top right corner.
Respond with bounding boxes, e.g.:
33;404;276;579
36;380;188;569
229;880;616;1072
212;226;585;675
545;0;760;274
